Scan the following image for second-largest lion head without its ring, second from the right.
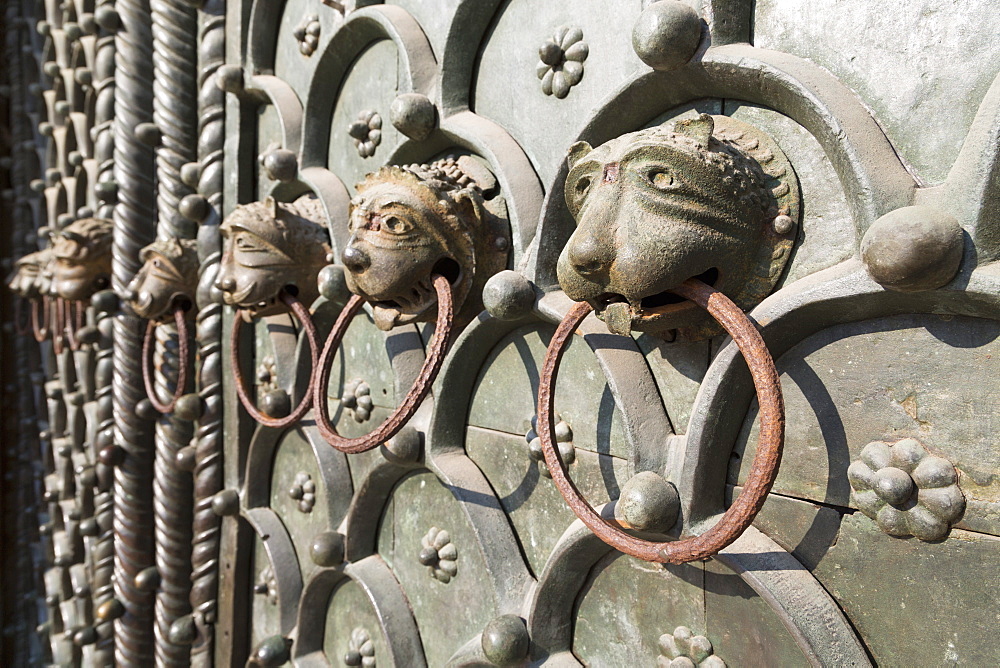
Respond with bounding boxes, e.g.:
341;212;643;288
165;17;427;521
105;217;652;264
342;157;510;330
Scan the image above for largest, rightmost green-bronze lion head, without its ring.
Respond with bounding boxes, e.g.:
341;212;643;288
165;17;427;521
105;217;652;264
558;114;799;339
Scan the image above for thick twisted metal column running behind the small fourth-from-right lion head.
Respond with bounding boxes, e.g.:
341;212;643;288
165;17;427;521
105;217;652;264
150;0;198;666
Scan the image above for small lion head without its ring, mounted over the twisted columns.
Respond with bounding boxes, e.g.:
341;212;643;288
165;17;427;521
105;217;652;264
125;238;198;321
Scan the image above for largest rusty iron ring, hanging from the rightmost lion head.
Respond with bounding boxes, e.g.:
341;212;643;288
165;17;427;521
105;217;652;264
538;279;785;564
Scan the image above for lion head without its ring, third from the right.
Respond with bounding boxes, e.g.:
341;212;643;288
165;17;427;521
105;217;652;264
215;196;330;321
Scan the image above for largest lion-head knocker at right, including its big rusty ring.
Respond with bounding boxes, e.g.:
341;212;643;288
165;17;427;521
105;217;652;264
538;114;799;563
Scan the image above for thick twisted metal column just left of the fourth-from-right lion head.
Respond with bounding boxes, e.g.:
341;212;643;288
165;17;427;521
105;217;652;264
112;0;155;668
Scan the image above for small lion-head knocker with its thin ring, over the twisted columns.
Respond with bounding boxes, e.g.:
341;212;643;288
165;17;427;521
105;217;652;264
125;238;198;413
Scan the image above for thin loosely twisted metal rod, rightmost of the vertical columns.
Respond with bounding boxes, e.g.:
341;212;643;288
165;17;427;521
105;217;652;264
191;0;226;667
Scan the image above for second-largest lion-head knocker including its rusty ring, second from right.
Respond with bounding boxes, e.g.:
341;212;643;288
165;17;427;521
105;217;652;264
313;156;510;453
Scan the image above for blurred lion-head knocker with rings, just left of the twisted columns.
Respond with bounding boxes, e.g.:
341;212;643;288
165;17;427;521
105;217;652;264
52;218;113;350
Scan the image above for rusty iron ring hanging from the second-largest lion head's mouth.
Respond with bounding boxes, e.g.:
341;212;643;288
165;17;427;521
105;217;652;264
313;274;455;454
